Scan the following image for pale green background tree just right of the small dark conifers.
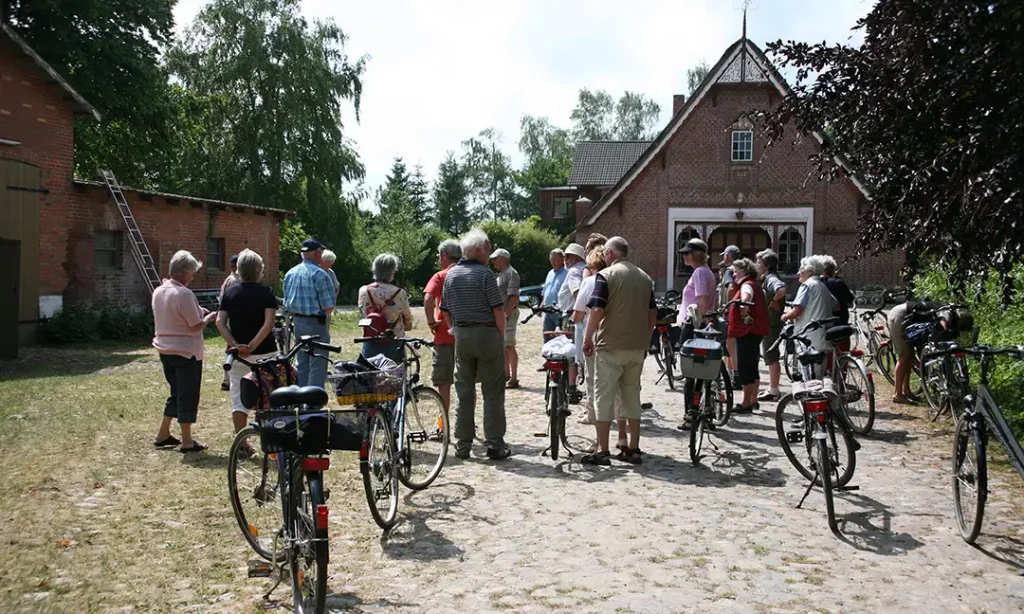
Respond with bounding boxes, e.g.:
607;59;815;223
462;128;516;220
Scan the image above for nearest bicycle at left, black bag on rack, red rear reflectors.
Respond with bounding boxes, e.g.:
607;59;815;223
224;336;346;614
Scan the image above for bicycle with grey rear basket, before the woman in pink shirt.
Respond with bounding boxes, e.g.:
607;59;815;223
679;299;754;465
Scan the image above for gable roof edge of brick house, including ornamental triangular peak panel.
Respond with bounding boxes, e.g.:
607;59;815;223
570;37;870;226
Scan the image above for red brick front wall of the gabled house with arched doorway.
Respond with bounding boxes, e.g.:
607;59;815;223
578;85;902;288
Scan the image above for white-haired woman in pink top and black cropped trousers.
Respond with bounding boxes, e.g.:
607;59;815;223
153;250;217;452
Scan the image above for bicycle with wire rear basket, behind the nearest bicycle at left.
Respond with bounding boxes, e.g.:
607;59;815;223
346;331;451;530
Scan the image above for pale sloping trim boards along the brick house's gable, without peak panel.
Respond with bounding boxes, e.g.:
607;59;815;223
580;40;870;226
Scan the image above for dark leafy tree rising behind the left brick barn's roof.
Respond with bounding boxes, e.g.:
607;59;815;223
0;0;174;187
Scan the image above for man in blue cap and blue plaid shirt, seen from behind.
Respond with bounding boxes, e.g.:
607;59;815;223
285;238;335;388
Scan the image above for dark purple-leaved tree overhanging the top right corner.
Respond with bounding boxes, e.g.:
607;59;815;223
763;0;1024;294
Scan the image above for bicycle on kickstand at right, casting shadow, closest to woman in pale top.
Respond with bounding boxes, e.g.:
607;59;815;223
772;318;860;533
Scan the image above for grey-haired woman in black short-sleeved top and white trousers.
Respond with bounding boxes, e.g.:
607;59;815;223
217;250;278;433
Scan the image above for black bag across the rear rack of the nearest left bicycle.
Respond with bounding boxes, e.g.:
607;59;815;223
259;411;364;455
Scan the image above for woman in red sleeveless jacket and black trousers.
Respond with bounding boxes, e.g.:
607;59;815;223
729;258;768;413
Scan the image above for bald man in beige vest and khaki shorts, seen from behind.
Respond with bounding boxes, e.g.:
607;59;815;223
582;236;657;465
